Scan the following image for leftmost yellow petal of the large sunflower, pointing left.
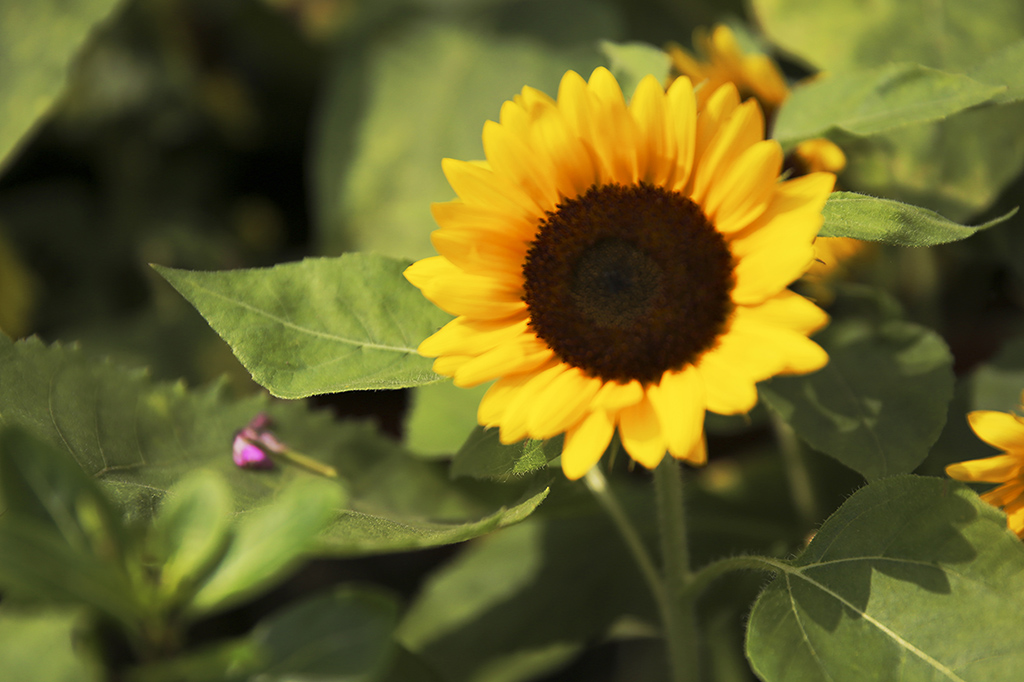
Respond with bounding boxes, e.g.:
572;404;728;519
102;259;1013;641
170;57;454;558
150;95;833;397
403;256;526;319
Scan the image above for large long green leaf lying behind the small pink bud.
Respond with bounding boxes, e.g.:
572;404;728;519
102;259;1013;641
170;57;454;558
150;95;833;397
0;336;545;554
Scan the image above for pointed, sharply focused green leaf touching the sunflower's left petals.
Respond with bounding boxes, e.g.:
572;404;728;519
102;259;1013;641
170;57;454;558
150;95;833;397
157;253;451;398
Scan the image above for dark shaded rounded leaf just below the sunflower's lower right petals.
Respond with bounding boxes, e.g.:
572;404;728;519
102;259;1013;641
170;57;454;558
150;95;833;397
759;307;953;480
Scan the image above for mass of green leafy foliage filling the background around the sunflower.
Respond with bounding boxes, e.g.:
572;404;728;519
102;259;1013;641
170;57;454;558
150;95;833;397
6;0;1024;682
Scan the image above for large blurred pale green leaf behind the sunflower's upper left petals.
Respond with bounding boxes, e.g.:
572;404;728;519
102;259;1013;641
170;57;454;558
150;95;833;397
312;18;600;259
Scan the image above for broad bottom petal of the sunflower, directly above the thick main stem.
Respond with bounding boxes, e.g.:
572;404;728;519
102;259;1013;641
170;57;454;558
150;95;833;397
647;367;705;459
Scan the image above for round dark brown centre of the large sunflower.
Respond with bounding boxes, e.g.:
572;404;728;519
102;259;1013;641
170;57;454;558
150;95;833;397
522;184;734;383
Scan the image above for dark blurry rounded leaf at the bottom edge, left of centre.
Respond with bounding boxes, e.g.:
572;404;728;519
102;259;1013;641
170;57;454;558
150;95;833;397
250;586;398;682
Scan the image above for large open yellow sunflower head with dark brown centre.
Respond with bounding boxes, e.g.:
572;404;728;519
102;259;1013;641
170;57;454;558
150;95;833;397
406;69;835;479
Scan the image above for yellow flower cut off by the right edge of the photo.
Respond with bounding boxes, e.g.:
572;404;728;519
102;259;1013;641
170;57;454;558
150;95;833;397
946;394;1024;538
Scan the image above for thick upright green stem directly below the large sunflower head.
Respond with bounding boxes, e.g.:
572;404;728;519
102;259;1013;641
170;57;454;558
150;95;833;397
654;457;700;682
